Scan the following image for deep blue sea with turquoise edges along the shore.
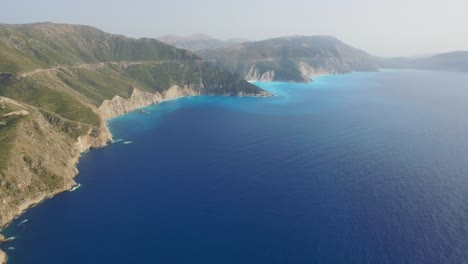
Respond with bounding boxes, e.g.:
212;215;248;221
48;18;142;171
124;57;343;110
4;70;468;264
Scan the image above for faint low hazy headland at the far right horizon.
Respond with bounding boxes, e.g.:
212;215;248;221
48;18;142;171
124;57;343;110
381;51;468;72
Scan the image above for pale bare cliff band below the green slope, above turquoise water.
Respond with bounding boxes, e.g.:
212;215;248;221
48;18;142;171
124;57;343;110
98;85;200;119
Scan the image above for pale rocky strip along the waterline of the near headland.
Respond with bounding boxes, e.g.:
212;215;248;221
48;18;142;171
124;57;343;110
0;86;273;264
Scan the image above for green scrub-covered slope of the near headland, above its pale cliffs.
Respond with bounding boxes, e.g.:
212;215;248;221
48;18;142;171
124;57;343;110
0;23;261;126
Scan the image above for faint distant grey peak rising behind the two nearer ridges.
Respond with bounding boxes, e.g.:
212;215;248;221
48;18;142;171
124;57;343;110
158;34;243;52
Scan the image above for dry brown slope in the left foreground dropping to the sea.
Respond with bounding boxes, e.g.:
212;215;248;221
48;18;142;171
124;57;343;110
0;97;111;226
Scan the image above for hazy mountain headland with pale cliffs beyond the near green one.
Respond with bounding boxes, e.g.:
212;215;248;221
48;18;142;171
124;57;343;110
197;36;377;82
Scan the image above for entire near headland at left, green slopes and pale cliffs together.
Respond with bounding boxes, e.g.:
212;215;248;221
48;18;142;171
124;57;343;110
0;23;269;233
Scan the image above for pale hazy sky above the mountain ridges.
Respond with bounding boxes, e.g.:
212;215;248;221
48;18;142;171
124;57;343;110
0;0;468;56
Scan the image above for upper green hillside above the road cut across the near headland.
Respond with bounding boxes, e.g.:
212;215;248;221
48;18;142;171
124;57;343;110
0;23;198;72
